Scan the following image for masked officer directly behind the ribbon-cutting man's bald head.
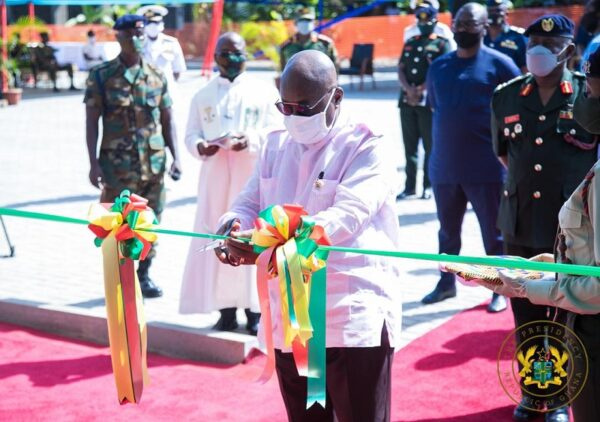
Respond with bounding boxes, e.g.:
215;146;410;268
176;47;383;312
279;10;339;70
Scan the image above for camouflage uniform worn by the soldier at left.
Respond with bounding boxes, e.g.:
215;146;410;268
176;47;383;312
84;57;171;217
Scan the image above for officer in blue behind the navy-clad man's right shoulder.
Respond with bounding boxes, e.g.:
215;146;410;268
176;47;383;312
483;0;527;73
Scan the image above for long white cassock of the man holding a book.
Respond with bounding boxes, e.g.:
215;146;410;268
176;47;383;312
179;72;282;314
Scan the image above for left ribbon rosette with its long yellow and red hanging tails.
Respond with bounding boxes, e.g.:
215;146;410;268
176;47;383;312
88;190;157;404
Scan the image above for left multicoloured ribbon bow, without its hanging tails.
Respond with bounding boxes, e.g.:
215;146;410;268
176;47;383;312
88;189;158;260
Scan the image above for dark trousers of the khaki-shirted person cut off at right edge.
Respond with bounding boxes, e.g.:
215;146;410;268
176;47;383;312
567;312;600;422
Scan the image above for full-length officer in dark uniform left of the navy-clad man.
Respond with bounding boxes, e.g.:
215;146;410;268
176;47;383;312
397;3;451;199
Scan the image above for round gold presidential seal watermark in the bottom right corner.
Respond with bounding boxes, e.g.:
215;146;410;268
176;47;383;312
498;321;588;412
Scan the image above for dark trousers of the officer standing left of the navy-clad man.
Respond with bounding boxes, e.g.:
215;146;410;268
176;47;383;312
400;104;433;192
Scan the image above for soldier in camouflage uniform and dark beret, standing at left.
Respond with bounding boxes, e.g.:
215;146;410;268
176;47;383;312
84;15;179;297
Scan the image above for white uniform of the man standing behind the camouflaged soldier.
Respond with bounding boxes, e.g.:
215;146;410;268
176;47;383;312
143;32;187;105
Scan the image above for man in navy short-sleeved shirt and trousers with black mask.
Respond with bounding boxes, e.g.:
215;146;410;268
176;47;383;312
423;3;521;312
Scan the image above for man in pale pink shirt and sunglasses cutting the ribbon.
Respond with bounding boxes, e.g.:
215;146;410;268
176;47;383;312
217;51;401;422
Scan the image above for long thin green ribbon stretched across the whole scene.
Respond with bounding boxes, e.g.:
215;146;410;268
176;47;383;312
0;207;600;278
